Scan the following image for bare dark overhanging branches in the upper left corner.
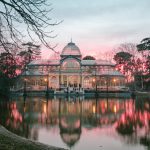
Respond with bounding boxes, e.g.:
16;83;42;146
0;0;60;50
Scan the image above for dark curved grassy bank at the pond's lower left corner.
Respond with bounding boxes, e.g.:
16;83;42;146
0;125;65;150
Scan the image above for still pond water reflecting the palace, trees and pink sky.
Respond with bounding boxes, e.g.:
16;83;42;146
0;97;150;150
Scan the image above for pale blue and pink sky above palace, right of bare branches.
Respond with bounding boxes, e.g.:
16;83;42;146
34;0;150;58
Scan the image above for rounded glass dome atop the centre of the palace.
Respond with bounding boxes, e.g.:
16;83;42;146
61;42;81;57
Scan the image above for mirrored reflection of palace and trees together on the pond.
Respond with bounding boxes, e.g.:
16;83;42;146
0;98;150;147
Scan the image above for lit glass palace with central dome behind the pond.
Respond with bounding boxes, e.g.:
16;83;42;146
14;42;127;92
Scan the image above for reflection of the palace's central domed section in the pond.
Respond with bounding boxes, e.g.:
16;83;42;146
59;101;82;147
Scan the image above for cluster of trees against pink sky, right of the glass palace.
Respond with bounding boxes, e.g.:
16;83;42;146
113;38;150;90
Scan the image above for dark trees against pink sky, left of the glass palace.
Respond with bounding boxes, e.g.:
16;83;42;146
0;42;41;95
